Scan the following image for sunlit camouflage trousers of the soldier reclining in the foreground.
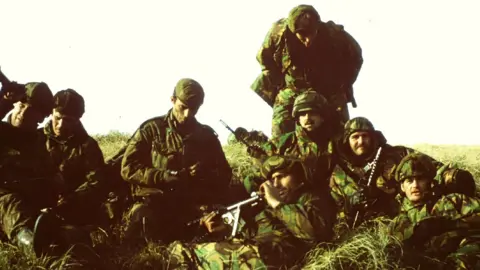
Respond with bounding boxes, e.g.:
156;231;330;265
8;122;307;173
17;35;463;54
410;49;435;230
169;239;268;270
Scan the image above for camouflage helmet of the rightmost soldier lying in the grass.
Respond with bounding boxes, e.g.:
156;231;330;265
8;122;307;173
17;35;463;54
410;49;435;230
395;153;437;183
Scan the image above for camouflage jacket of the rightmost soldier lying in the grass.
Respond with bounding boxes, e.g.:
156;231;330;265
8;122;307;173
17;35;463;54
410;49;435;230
390;193;480;260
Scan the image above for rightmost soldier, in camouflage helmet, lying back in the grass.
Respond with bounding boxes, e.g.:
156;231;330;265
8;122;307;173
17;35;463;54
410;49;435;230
391;153;480;269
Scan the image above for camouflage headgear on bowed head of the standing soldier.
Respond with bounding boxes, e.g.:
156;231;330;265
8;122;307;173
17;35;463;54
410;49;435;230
287;5;320;33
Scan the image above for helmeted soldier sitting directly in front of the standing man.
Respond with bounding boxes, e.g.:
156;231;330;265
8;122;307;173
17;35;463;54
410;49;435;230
249;89;342;194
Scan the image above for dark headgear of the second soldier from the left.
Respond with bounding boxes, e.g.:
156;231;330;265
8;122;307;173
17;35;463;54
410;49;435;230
53;89;85;118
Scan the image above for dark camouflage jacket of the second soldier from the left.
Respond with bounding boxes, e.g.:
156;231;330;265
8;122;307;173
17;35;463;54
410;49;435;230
43;121;108;204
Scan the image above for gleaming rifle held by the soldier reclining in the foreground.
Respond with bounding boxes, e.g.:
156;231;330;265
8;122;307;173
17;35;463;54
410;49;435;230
187;192;263;238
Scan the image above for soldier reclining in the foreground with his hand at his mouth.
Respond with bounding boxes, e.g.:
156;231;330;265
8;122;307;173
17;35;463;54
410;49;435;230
168;156;335;269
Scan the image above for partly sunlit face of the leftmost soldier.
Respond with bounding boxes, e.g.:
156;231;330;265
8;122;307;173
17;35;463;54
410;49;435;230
10;101;44;129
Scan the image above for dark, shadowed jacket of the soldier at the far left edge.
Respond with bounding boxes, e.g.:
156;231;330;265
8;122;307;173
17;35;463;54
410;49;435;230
0;122;59;208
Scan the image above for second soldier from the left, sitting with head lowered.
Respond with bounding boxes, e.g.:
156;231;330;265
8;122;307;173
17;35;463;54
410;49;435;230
43;89;107;229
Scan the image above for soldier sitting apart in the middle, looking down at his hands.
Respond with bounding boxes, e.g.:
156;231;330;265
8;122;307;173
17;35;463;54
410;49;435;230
121;78;232;243
